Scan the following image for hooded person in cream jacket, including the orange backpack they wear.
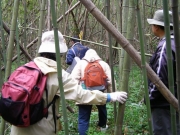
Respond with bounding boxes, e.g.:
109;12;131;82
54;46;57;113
71;49;112;135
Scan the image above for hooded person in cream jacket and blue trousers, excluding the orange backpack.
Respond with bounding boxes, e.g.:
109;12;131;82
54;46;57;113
71;49;112;135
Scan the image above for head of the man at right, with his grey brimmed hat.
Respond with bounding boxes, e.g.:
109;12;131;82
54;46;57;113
147;10;173;38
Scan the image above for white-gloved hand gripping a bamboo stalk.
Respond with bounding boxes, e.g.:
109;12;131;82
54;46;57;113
109;91;127;104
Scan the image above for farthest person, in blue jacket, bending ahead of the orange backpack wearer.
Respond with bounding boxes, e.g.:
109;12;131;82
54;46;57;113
66;36;89;73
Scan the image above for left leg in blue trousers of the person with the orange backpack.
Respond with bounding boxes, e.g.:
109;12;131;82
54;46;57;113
78;105;92;135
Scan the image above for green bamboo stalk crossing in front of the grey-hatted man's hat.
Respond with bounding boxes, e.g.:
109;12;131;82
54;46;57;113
163;0;177;135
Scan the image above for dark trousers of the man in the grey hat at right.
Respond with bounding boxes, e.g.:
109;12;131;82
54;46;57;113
152;108;180;135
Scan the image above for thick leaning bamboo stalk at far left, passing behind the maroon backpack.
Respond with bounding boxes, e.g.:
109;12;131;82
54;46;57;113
0;0;20;135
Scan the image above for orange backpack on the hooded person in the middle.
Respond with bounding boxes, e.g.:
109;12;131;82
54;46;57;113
81;60;107;91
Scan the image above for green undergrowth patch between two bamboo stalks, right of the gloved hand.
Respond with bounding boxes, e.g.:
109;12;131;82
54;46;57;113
123;66;148;135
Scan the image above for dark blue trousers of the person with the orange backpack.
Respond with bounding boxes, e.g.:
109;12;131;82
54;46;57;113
78;105;107;135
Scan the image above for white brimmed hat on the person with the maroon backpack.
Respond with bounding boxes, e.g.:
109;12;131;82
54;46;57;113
38;31;68;53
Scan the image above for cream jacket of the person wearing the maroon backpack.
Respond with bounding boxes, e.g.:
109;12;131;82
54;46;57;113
11;57;107;135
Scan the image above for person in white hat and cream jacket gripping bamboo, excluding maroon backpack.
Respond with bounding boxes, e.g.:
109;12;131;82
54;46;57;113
7;31;127;135
